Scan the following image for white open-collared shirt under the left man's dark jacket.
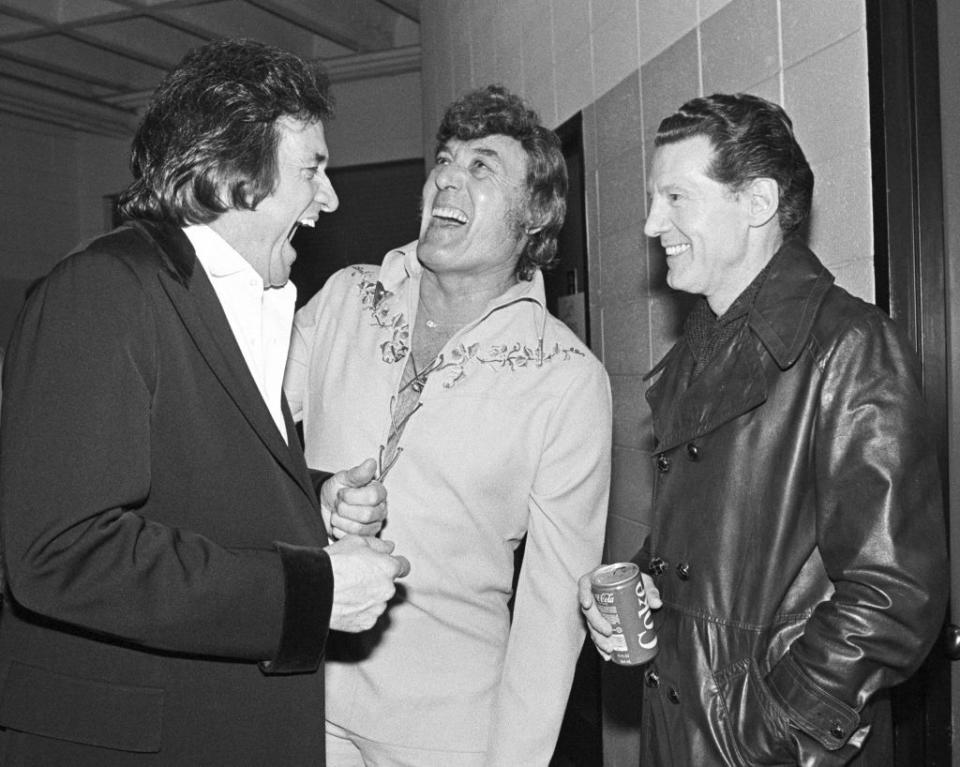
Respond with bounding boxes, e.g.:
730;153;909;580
183;225;297;441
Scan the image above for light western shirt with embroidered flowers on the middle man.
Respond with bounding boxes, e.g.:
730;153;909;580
285;243;611;767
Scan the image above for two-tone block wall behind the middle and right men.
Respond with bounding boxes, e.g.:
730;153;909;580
421;0;874;767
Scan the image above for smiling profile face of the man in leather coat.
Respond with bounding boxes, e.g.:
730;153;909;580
644;136;752;314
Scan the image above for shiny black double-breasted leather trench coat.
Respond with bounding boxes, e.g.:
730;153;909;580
638;244;947;767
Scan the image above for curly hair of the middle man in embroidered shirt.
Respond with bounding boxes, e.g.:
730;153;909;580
437;85;567;280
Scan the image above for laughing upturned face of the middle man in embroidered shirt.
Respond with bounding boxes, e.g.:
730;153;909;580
417;135;527;281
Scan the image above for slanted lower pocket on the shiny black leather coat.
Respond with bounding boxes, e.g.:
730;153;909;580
711;658;797;767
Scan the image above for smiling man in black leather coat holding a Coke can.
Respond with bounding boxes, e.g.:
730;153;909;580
580;95;947;767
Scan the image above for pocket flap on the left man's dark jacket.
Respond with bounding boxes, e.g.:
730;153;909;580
0;661;164;753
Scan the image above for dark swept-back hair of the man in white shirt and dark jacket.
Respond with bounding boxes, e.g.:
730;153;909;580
120;40;333;226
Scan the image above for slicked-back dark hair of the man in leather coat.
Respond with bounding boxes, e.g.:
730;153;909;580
654;93;813;239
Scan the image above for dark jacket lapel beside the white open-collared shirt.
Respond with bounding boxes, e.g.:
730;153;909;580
136;222;316;504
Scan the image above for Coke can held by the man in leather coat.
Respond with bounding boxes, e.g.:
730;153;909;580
590;562;660;666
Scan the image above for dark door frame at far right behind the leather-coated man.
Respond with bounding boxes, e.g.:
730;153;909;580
866;0;951;767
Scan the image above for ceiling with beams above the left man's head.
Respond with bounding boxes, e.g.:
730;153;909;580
0;0;420;136
